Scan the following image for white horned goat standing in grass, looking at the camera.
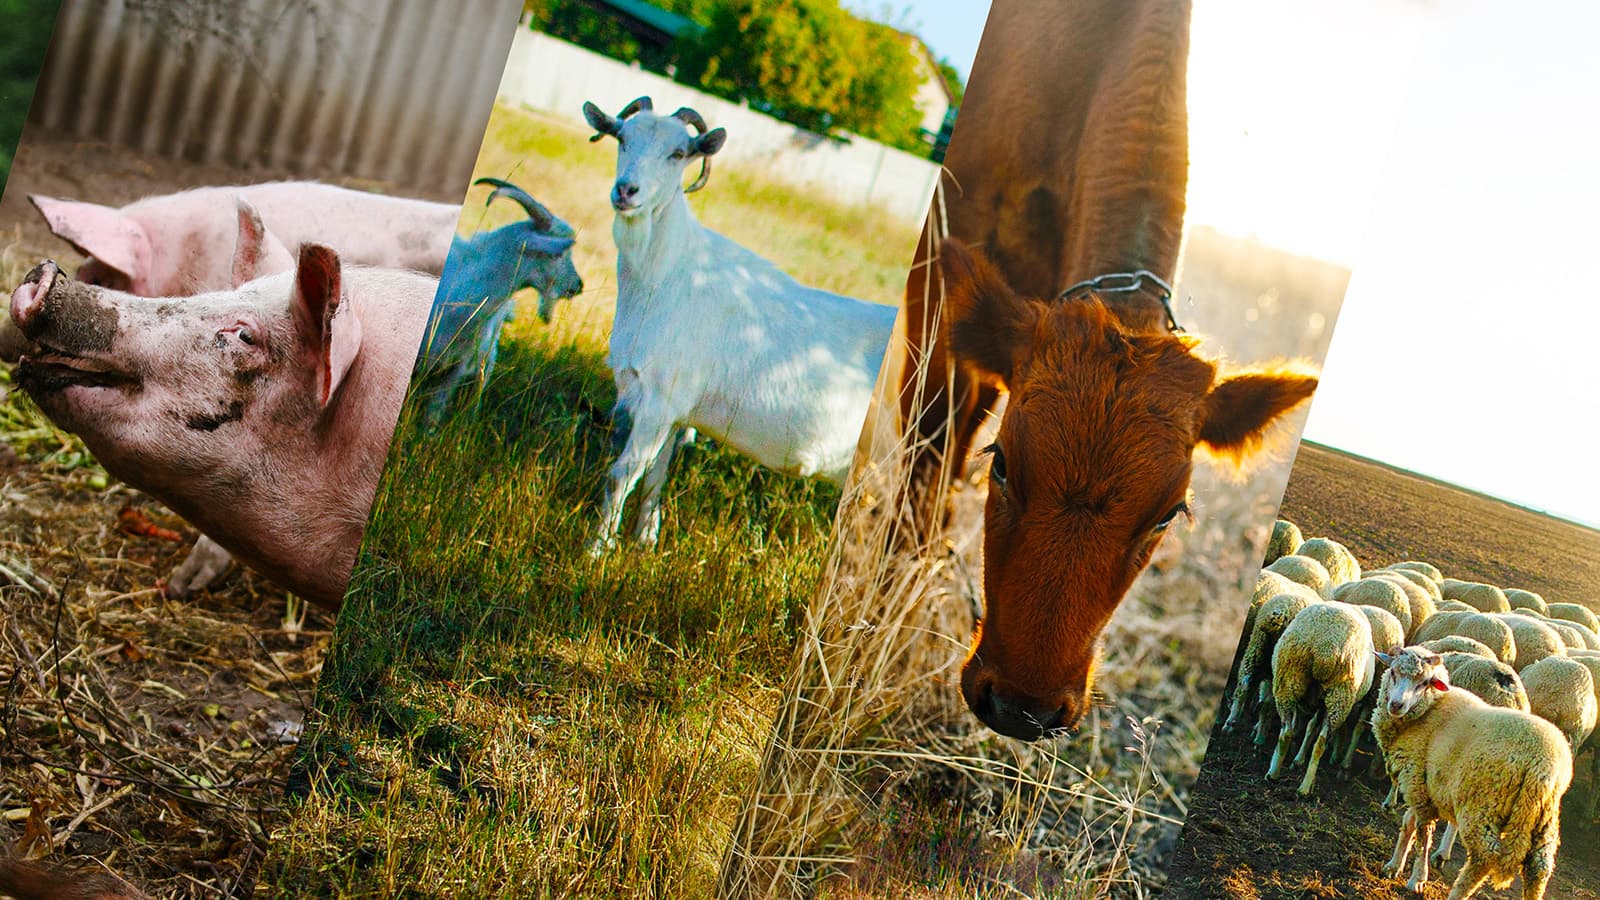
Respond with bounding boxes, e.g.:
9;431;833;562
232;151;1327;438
584;98;894;554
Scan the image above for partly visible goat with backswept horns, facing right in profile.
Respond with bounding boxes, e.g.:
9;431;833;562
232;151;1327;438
418;178;584;421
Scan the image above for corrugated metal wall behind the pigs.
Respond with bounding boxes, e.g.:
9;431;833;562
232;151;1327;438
29;0;522;192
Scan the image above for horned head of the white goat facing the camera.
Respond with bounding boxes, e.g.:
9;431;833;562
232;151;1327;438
584;96;728;218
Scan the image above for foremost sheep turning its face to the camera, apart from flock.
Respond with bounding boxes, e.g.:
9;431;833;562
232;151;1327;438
1373;647;1573;900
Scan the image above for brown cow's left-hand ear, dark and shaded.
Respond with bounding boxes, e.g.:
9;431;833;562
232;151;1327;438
939;237;1040;384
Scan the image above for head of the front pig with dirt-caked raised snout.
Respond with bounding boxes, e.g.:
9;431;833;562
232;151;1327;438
11;245;362;500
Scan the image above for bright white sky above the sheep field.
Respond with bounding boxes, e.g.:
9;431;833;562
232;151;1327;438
1306;0;1600;525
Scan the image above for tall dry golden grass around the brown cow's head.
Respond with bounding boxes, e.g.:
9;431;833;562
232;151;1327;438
720;219;1344;897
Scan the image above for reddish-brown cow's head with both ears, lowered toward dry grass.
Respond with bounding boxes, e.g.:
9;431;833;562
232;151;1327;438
939;240;1317;740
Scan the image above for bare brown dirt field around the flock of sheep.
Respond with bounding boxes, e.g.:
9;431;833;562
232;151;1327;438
1168;444;1600;900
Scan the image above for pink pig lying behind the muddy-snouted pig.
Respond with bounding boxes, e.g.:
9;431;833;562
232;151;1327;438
29;181;461;296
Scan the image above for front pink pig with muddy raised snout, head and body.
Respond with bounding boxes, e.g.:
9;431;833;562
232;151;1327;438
11;243;437;609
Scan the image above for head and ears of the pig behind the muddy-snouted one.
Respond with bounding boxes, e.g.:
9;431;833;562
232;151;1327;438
29;191;294;296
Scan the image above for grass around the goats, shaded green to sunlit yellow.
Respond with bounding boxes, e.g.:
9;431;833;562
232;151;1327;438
262;107;914;897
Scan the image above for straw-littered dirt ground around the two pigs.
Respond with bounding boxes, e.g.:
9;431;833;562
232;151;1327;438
0;127;459;897
